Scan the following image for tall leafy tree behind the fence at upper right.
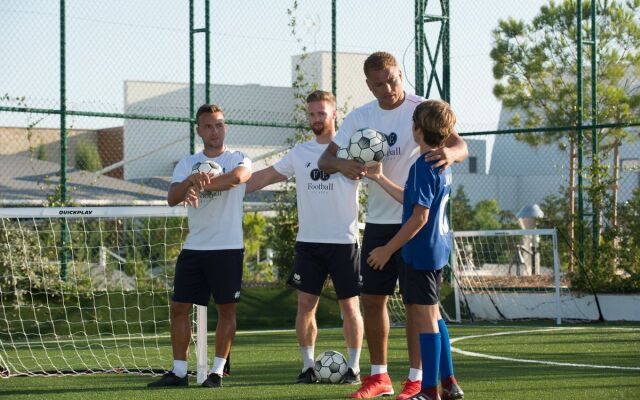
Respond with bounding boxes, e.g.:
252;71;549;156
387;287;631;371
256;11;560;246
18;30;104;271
491;0;640;266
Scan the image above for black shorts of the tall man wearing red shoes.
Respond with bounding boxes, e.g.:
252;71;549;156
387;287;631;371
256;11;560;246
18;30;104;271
360;223;404;295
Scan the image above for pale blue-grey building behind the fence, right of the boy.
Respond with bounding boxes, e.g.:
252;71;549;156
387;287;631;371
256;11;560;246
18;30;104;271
453;106;640;212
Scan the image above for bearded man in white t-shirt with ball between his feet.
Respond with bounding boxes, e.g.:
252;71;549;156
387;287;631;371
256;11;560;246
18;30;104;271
247;90;363;385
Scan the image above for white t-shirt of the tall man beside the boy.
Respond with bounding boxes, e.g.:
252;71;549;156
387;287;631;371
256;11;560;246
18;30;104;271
333;93;425;224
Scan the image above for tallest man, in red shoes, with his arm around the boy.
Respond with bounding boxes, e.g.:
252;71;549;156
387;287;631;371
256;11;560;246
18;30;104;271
318;52;468;400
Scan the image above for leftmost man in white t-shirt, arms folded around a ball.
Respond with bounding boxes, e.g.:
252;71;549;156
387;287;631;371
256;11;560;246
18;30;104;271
148;104;251;387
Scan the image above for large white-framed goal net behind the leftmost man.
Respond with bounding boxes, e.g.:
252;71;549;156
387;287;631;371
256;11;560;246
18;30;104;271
0;207;207;377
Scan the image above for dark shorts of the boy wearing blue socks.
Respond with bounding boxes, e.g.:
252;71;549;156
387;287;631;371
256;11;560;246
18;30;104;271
400;264;442;306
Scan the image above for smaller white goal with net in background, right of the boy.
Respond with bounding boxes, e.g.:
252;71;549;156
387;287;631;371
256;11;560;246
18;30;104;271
389;229;598;325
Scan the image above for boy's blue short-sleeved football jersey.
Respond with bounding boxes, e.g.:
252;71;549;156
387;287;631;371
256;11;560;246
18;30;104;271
402;156;451;270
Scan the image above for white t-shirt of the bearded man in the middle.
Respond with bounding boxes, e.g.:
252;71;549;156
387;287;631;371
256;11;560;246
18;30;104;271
273;139;358;243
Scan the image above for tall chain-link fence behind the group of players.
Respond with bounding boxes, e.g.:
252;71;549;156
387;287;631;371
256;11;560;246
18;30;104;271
0;0;640;286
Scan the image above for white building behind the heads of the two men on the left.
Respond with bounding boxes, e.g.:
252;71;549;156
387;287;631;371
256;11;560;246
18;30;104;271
123;52;373;180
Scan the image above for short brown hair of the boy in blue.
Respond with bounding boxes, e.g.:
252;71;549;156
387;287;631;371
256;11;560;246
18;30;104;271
413;100;456;147
